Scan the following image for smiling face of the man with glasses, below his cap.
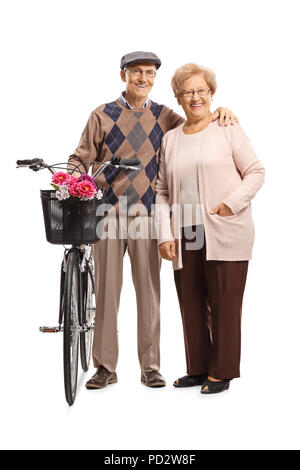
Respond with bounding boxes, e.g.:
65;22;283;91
121;63;156;99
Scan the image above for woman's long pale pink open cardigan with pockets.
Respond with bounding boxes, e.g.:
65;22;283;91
155;121;265;269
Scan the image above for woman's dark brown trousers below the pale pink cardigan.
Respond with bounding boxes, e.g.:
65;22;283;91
174;226;248;379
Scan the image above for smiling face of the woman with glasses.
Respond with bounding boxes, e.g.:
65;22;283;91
177;74;211;121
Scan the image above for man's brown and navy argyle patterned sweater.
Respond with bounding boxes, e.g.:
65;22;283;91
69;100;183;215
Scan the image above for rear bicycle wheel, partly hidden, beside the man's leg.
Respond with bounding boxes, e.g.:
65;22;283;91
80;263;96;372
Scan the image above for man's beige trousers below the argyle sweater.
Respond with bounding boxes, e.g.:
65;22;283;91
93;217;161;372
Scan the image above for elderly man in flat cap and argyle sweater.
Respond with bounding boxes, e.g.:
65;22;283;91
69;52;235;389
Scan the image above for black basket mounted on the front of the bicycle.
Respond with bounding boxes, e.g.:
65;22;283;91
41;189;102;245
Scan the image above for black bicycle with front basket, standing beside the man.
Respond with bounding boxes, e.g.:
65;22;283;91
17;156;139;406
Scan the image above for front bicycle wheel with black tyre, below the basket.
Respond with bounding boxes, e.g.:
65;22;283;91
63;252;80;405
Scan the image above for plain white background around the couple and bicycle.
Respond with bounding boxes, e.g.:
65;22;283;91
0;0;300;449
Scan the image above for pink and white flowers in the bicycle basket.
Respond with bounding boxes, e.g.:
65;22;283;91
51;171;103;201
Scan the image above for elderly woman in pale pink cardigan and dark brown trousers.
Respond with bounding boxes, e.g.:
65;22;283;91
155;63;264;394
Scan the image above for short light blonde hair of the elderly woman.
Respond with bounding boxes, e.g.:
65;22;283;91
171;62;217;97
